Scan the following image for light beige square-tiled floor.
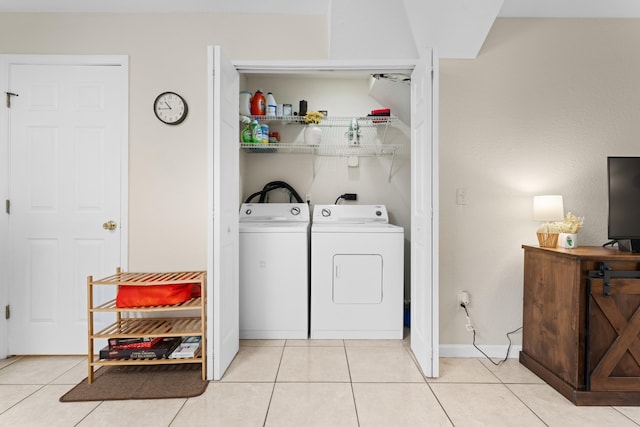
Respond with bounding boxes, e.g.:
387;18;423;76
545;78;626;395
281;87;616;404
0;340;640;427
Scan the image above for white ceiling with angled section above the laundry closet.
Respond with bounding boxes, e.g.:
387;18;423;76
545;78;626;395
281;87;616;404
0;0;640;59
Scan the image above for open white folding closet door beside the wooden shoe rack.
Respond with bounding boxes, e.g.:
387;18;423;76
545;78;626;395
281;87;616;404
207;46;240;380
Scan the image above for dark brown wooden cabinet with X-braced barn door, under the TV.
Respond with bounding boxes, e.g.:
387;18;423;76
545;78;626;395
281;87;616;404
520;246;640;405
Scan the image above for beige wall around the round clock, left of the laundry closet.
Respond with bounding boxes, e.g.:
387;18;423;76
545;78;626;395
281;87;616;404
0;14;328;270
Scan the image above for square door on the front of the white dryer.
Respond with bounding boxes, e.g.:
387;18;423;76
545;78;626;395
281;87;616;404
333;254;382;304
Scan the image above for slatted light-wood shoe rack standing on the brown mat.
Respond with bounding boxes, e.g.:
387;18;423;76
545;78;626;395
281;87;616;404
87;269;207;384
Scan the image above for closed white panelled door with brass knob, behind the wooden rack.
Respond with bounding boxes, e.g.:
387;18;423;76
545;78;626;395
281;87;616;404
8;60;127;354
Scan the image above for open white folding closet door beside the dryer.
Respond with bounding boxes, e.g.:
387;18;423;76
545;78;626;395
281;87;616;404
411;51;439;377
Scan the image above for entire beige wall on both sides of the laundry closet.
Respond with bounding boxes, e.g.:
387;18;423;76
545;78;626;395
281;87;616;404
5;14;640;345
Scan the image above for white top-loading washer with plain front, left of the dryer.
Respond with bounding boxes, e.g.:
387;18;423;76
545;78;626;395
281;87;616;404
239;203;309;339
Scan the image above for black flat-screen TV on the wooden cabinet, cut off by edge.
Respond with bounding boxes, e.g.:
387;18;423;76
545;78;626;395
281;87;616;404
607;157;640;252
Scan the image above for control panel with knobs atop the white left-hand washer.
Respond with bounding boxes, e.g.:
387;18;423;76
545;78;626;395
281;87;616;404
239;203;309;224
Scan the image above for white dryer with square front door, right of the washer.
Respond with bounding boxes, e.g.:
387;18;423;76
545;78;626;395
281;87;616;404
310;205;404;339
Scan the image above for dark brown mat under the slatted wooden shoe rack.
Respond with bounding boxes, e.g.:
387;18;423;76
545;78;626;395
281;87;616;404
60;363;209;402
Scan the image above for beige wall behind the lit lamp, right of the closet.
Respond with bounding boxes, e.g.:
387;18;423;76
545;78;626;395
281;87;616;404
440;19;640;345
